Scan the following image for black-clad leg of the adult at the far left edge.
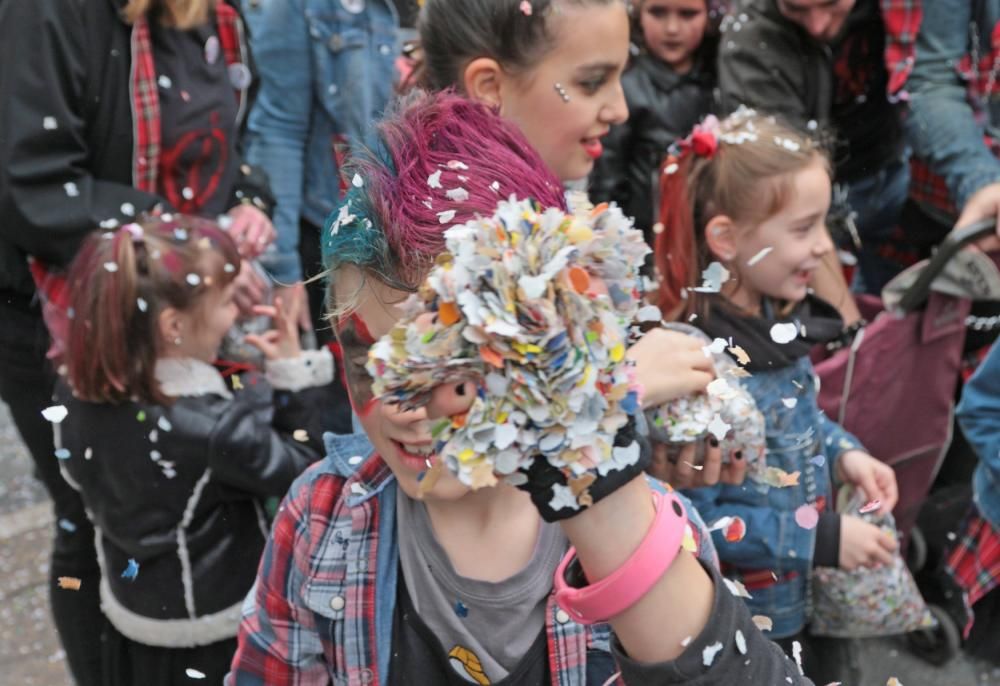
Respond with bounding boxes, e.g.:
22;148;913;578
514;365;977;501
0;300;103;686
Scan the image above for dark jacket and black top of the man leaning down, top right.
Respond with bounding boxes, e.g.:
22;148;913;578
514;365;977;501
718;0;904;181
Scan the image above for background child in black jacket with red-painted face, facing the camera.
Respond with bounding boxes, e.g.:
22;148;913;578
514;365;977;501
590;0;721;245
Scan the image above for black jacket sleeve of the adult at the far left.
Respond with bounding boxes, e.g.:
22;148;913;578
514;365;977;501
0;0;160;266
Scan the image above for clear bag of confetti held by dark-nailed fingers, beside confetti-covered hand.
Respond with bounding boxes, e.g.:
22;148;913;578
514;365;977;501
646;323;767;478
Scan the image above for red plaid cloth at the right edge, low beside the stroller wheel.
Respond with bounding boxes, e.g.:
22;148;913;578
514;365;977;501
945;512;1000;638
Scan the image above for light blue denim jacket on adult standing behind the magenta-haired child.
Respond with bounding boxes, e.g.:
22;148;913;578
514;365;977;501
243;0;399;283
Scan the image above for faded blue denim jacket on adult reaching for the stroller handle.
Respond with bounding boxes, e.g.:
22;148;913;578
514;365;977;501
900;0;1000;210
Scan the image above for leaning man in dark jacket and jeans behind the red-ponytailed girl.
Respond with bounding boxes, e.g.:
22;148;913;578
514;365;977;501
719;0;909;292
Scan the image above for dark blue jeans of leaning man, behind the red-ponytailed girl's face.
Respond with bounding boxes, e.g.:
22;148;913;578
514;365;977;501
842;153;910;295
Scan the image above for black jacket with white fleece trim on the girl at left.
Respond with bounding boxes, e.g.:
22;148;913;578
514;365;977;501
56;349;333;647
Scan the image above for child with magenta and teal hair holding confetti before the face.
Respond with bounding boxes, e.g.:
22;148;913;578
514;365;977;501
228;94;808;686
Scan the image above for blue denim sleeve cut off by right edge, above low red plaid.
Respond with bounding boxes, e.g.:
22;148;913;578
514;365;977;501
958;345;1000;531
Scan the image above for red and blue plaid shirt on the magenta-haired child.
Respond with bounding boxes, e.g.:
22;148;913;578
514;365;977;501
232;434;717;686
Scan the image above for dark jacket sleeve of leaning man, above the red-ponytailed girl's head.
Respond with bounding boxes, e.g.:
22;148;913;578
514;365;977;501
718;28;809;126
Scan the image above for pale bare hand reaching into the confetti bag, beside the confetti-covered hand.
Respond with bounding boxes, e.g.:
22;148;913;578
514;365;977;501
626;329;715;407
